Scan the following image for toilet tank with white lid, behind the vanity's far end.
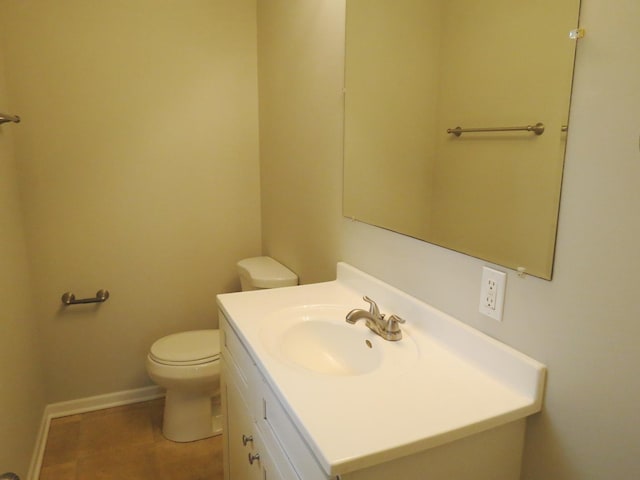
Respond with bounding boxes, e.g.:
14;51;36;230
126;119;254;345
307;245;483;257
237;257;298;292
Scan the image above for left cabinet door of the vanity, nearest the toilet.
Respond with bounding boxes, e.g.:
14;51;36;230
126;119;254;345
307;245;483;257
221;369;263;480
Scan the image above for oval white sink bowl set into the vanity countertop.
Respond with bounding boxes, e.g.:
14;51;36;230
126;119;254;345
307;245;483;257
260;305;418;376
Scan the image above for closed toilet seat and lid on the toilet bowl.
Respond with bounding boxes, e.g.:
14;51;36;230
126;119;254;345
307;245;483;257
149;330;220;367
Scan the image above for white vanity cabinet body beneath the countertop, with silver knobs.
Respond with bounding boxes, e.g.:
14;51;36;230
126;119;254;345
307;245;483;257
219;312;525;480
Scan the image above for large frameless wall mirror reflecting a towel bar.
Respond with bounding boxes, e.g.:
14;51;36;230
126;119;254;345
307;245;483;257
344;0;580;279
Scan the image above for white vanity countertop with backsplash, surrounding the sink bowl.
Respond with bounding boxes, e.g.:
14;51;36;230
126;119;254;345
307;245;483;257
218;263;545;475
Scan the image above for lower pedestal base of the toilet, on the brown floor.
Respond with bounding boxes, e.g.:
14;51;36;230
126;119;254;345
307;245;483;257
162;390;222;442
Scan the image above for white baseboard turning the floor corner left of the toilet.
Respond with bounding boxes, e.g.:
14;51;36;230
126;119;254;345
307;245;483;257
27;385;165;480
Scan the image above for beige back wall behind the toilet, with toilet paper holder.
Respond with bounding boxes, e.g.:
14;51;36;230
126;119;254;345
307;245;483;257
0;0;261;402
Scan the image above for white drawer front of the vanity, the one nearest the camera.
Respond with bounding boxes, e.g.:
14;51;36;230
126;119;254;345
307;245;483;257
258;383;327;480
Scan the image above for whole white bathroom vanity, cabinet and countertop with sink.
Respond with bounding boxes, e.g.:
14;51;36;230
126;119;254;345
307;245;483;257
218;263;545;480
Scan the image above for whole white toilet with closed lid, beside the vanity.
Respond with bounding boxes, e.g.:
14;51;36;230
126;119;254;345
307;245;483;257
146;257;298;442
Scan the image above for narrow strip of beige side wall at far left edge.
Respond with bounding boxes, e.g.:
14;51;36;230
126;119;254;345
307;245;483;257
0;44;45;478
